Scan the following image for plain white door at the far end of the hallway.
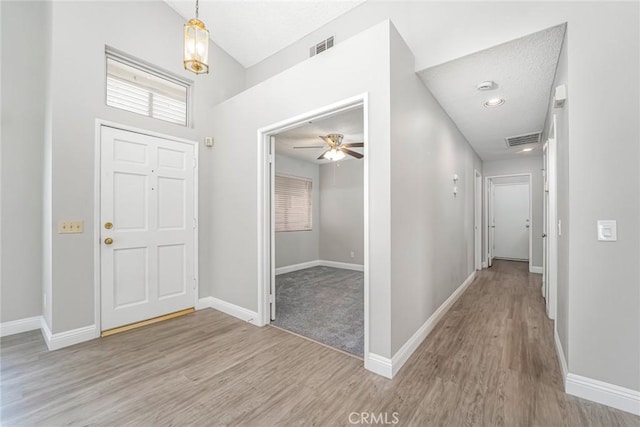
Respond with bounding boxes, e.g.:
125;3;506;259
493;183;530;260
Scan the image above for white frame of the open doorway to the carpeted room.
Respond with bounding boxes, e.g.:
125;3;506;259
257;93;369;361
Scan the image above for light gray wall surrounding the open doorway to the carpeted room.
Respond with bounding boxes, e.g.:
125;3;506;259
210;22;390;357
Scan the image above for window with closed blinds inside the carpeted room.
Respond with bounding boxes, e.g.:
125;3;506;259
275;175;313;231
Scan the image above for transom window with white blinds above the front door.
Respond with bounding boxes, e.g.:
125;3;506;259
106;49;191;126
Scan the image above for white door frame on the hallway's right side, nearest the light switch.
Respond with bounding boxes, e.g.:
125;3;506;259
543;114;558;319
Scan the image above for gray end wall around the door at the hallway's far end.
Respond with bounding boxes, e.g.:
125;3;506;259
482;155;544;267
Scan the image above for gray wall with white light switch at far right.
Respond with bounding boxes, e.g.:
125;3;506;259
562;2;640;390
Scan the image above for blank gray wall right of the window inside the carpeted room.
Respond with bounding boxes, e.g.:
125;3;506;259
320;160;364;265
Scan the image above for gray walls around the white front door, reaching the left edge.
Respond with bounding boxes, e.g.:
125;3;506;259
2;1;244;333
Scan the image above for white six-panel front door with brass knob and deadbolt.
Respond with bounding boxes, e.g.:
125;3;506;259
100;126;197;330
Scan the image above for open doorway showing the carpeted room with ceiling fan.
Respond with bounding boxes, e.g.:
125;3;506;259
258;95;369;360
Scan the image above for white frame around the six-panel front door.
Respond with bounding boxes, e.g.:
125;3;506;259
93;119;200;338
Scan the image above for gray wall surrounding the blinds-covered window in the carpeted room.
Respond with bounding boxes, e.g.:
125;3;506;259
275;154;321;268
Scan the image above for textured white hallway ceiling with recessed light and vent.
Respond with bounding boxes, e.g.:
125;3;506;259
418;24;565;160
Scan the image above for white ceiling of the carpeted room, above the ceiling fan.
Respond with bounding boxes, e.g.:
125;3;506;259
276;107;364;165
